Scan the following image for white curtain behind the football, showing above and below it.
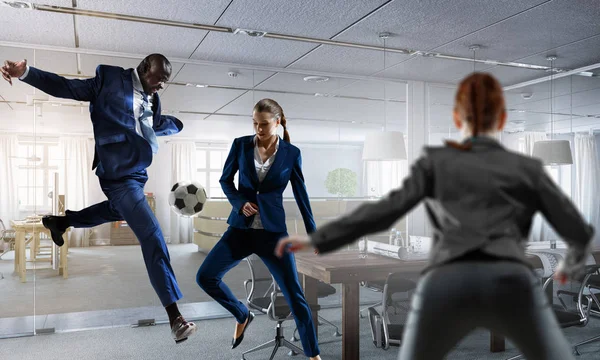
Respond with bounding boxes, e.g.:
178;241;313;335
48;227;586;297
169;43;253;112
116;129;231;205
169;141;196;244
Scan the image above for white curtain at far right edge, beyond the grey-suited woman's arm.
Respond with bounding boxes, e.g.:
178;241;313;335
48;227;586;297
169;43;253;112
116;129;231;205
573;135;600;245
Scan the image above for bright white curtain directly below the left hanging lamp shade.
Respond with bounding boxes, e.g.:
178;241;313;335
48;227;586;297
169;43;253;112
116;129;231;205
363;160;407;197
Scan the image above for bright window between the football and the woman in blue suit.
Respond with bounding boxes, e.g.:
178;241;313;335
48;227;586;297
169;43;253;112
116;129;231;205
196;146;230;198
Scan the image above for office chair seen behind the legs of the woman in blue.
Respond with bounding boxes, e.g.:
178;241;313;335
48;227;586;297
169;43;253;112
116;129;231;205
242;255;319;360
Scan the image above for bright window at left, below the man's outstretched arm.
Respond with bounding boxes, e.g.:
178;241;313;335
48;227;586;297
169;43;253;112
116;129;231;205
16;141;59;212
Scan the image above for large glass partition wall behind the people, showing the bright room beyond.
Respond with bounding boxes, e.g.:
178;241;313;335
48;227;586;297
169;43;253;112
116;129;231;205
0;40;600;342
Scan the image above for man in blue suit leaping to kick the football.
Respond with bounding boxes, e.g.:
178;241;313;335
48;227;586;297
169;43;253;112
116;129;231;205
0;54;196;343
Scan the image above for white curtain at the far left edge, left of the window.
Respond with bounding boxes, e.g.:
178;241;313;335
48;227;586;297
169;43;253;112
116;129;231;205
0;135;19;231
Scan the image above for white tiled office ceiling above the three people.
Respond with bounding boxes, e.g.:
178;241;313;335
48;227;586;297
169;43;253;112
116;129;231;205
0;0;600;135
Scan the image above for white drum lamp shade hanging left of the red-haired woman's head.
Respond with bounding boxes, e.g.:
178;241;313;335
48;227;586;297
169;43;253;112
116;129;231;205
363;131;406;160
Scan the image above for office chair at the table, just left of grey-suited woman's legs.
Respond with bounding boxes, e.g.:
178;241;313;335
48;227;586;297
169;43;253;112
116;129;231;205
367;272;417;350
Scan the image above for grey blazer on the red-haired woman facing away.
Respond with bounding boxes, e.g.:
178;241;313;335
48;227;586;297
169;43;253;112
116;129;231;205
310;137;594;270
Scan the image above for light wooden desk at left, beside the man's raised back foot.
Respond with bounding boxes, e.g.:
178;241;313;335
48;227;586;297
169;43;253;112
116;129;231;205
10;220;70;282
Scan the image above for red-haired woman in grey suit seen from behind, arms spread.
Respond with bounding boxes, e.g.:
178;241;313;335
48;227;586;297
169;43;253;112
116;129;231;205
276;73;594;360
